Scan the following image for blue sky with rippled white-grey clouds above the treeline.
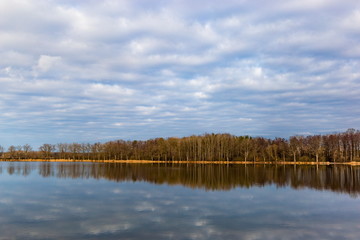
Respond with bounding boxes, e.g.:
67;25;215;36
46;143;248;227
0;0;360;147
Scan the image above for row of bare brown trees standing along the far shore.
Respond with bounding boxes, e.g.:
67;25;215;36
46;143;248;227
0;129;360;162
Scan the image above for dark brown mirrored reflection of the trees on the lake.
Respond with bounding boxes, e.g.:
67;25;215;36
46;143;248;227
0;162;360;195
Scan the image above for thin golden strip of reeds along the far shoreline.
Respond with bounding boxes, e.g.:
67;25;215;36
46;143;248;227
0;159;360;166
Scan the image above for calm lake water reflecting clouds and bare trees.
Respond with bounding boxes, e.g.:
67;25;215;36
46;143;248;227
0;162;360;240
